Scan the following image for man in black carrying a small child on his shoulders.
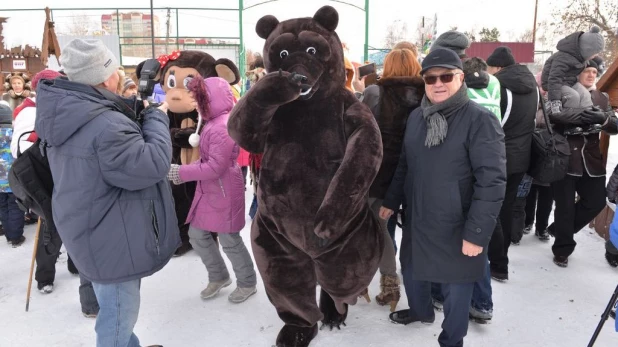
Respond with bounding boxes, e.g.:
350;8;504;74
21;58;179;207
548;59;618;267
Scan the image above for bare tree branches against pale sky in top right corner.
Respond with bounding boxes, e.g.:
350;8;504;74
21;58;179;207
551;0;618;65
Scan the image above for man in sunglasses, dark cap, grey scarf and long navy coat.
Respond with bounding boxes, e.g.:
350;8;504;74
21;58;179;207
380;48;506;347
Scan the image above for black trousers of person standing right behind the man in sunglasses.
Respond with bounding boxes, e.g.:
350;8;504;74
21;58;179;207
488;173;525;273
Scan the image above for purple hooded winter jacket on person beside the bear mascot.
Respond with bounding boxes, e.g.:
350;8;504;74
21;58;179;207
179;77;245;233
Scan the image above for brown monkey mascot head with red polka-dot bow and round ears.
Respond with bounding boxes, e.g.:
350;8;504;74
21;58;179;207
135;51;240;113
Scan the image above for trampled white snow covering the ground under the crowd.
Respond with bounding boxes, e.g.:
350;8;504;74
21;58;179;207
0;145;618;347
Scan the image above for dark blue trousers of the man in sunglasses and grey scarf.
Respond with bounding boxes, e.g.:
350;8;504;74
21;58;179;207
402;266;474;347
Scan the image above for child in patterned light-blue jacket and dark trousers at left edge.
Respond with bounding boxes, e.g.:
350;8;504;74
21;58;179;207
0;104;26;248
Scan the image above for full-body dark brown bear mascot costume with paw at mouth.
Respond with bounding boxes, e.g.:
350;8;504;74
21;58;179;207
228;6;384;347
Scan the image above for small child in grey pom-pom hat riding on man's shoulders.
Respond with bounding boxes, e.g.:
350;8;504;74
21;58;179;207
541;26;605;115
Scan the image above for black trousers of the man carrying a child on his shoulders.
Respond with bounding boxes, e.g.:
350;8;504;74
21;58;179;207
549;172;605;257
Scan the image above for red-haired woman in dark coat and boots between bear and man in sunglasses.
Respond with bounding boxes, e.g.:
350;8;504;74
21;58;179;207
361;49;425;311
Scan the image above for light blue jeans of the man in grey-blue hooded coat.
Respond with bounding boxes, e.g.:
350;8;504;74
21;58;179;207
92;279;141;347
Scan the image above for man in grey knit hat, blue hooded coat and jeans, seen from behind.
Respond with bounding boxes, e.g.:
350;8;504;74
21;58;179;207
35;39;180;347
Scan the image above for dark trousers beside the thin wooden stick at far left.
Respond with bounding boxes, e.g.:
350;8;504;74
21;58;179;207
34;221;62;289
